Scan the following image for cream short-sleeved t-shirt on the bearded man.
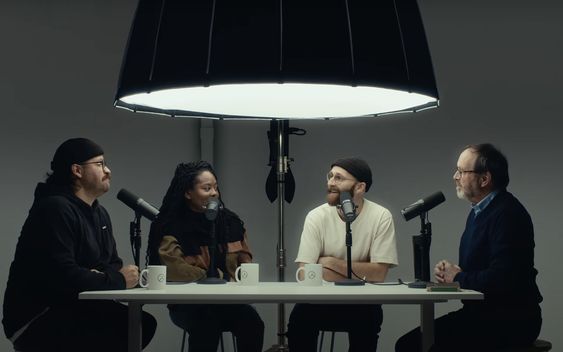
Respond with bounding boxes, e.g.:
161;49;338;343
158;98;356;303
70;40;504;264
295;199;399;267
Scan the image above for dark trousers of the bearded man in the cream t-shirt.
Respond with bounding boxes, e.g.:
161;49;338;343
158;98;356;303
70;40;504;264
287;304;383;352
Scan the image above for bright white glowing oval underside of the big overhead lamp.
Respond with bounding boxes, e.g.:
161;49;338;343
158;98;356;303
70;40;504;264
121;83;436;119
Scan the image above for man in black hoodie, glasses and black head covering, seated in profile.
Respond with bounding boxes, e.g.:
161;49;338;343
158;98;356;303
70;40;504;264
2;138;156;352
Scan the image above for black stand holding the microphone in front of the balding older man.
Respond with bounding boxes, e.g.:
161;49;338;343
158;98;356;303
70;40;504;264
409;212;432;288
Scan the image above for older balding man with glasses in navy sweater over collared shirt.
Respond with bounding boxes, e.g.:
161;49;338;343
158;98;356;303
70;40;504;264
395;143;542;352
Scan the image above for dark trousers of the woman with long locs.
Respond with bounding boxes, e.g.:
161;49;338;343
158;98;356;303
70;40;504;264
168;304;264;352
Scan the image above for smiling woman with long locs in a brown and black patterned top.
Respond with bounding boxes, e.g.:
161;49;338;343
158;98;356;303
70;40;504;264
147;161;264;352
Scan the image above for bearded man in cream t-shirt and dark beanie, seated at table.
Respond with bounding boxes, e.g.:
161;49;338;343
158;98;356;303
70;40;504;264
287;158;398;352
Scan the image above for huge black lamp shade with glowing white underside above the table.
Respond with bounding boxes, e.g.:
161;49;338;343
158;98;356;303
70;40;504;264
115;0;439;119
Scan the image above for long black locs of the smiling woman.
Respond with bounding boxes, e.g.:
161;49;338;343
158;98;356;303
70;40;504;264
147;160;223;264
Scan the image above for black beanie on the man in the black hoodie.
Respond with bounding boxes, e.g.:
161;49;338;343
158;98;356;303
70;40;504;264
51;138;104;174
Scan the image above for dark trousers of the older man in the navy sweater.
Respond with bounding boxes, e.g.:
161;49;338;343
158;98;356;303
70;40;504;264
395;305;542;352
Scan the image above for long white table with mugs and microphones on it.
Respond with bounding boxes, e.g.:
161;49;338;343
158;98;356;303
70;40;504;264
80;282;483;352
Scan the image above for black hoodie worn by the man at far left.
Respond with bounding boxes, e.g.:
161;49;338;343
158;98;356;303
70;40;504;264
2;183;126;338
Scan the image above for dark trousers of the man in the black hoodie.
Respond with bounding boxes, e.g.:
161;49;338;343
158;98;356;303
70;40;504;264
14;301;156;352
